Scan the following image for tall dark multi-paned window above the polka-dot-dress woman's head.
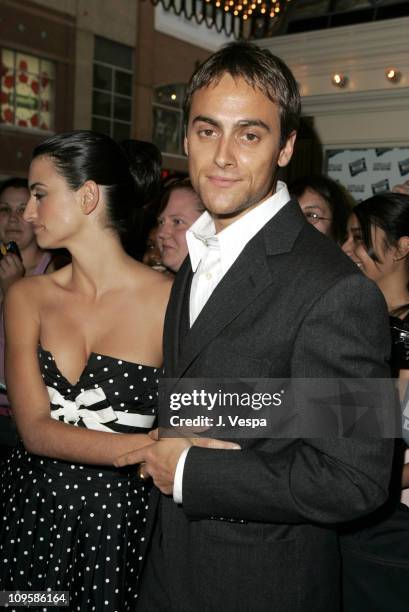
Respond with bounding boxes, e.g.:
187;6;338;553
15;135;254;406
92;36;133;140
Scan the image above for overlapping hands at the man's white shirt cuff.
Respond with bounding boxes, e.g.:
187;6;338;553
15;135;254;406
114;430;240;495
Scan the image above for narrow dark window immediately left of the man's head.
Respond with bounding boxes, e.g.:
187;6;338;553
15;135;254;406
153;83;186;156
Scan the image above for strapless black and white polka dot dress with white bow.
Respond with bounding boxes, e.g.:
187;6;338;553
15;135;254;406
0;348;159;612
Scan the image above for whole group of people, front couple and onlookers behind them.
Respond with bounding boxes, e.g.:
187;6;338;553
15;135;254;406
0;43;409;612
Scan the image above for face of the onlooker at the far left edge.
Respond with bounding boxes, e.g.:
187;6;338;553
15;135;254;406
0;187;35;251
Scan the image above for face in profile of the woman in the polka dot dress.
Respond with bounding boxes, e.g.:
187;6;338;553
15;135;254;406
24;157;83;248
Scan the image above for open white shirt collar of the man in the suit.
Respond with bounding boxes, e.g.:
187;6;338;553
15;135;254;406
186;181;290;274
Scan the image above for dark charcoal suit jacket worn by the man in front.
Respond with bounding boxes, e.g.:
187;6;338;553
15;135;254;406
138;201;393;612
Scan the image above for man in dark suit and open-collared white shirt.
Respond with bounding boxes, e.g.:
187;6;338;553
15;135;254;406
118;43;392;612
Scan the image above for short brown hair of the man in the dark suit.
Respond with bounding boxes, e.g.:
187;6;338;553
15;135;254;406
183;42;301;146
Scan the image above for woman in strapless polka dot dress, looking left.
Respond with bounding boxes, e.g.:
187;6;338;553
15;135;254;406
0;131;170;612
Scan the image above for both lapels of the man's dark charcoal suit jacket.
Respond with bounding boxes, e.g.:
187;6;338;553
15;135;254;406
164;201;306;378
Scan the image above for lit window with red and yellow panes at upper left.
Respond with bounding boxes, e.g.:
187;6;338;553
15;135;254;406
0;49;55;130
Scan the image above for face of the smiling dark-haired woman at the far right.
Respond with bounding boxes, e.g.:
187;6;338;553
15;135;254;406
342;214;395;284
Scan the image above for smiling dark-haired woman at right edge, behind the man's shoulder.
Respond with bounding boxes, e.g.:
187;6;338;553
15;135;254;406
342;193;409;612
